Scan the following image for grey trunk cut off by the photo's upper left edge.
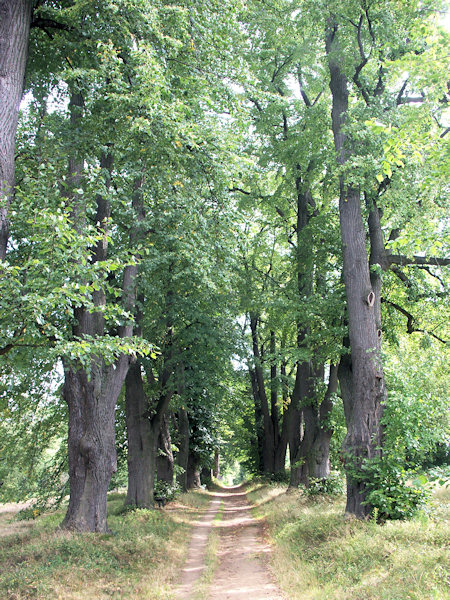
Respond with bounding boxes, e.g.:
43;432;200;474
0;0;33;260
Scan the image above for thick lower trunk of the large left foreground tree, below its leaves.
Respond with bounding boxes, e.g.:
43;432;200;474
62;357;128;533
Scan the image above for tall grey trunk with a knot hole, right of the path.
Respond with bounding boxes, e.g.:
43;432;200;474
326;21;386;517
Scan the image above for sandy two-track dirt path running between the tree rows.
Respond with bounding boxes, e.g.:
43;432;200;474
177;487;283;600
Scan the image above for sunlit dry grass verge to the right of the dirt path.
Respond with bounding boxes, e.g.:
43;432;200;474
249;486;450;600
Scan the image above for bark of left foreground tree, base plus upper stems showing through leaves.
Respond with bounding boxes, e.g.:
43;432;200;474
62;93;137;532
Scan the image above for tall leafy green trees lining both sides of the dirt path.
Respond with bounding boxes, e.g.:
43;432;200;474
0;0;450;532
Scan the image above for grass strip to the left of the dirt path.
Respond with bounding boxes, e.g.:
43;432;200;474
0;492;209;600
